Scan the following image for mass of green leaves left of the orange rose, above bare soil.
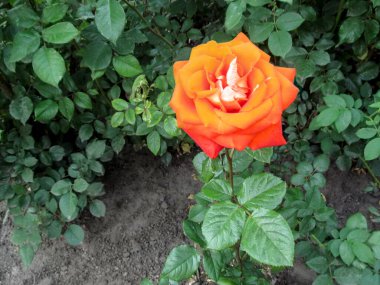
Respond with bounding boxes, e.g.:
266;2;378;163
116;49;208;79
0;0;196;266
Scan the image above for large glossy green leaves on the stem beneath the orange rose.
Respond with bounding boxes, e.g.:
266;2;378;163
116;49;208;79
156;149;295;284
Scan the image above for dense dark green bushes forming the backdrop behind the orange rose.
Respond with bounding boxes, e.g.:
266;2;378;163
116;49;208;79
0;0;380;284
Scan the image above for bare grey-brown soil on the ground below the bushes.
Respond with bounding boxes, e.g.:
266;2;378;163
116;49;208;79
0;151;379;285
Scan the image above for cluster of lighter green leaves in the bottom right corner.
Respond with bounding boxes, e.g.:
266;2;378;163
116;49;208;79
296;213;380;284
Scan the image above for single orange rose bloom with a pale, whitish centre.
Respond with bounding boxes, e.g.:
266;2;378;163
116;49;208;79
170;33;298;158
